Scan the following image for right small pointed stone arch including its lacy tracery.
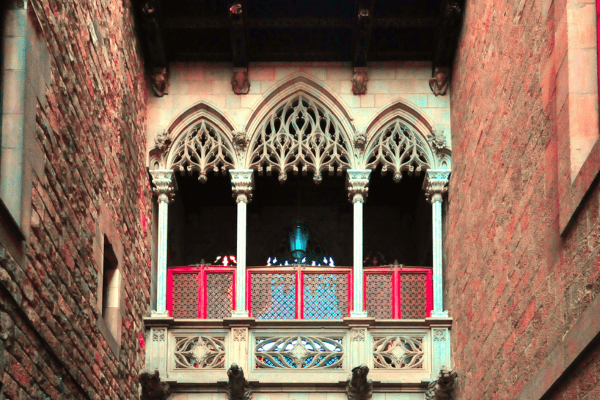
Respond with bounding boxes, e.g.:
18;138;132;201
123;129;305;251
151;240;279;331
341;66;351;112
360;99;451;181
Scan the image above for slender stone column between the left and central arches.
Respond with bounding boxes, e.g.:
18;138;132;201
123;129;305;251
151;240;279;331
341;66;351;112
229;169;254;318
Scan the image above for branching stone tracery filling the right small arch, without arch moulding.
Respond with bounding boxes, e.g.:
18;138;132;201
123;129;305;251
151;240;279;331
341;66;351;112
365;119;431;182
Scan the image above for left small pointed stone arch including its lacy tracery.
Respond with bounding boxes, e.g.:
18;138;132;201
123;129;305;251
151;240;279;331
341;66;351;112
150;101;240;181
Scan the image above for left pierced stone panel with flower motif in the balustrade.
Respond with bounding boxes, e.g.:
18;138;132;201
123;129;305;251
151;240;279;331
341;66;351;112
174;335;225;369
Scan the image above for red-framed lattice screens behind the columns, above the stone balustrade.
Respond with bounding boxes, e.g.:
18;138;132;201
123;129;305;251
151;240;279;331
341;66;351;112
167;266;433;319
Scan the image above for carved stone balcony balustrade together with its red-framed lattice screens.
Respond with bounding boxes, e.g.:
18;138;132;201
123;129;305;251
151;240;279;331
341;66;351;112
145;266;451;388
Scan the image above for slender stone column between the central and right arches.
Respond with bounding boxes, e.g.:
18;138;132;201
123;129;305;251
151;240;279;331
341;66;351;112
348;169;371;318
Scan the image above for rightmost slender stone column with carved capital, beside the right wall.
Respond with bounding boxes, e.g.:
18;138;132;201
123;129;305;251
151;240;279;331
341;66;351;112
423;169;450;318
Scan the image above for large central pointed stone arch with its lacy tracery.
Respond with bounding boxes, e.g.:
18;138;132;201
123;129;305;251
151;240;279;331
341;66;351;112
244;73;355;183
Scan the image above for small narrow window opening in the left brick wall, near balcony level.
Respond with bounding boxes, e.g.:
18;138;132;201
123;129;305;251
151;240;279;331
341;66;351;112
102;236;119;338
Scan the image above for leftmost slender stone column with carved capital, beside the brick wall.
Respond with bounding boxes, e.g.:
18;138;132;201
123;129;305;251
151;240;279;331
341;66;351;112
150;170;177;316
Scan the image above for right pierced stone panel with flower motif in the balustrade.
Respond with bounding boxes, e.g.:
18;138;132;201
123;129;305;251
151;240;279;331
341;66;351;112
373;336;425;369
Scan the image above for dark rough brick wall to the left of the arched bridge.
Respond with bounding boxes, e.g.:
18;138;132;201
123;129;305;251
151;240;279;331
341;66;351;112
0;0;150;400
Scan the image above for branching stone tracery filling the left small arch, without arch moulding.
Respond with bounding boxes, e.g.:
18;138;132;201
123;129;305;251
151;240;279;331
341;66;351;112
172;121;235;181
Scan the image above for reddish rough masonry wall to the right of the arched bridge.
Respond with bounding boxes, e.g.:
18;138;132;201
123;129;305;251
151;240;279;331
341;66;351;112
445;0;600;399
